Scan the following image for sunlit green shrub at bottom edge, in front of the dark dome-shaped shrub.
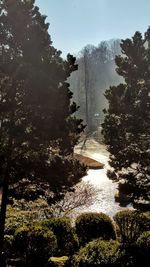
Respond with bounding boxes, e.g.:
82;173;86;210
71;240;120;267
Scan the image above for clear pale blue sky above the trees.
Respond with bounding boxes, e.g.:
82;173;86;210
35;0;150;57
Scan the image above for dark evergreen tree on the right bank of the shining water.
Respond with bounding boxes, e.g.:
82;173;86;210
103;28;150;208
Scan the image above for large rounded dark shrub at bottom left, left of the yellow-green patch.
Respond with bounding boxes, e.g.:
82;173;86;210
14;225;57;267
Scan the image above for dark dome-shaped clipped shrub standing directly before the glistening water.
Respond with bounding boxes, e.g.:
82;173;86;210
75;212;116;244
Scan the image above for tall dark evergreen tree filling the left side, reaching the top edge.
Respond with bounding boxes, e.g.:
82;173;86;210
0;0;83;260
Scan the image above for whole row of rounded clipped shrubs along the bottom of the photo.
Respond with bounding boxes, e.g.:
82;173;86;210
4;210;150;267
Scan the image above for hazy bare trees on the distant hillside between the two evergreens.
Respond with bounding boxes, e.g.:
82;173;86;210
69;39;121;132
